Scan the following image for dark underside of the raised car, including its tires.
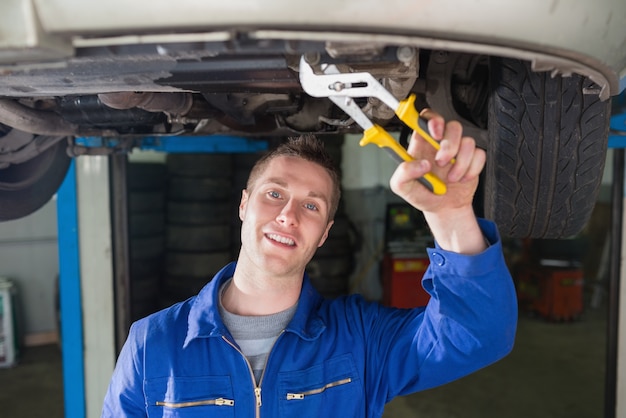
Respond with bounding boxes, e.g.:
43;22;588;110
0;34;610;238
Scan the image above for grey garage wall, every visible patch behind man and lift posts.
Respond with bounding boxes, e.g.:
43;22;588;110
0;140;612;344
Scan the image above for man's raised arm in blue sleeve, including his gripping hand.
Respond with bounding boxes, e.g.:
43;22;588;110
368;112;517;401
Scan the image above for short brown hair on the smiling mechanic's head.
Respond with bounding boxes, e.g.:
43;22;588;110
246;135;341;221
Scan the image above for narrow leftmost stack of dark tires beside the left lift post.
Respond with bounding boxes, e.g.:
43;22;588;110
126;163;167;321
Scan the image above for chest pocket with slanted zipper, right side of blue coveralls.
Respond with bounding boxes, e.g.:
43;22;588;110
279;354;364;418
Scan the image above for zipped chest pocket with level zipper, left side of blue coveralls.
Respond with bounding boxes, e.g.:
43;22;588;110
145;376;235;418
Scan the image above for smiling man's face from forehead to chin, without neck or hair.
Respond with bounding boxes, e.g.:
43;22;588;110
239;156;332;276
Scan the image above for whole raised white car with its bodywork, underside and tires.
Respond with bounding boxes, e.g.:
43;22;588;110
0;0;626;238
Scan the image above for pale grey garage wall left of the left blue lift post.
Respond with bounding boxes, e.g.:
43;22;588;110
0;199;59;344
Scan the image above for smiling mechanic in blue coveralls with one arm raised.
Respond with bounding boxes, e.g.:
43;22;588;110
102;111;517;418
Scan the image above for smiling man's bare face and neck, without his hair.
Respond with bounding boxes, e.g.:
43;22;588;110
227;152;339;315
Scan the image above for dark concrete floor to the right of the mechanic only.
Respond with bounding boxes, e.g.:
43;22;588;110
383;310;606;418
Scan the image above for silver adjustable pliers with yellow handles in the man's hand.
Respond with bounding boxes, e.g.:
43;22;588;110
299;56;446;195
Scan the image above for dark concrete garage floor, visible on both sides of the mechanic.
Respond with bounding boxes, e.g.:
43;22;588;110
0;310;606;418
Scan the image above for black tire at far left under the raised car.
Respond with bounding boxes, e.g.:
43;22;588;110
0;138;72;222
